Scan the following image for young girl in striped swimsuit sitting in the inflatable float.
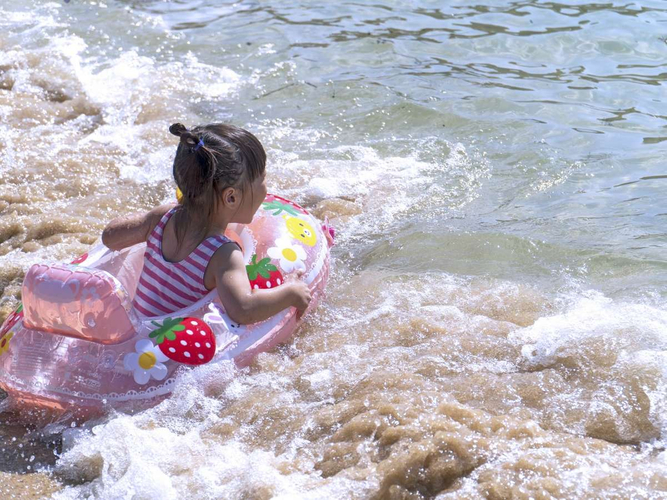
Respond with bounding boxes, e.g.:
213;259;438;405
102;123;311;324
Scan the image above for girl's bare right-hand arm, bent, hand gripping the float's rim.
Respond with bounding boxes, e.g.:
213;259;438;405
209;243;311;324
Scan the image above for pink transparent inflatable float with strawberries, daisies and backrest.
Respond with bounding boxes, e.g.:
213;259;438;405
0;195;332;416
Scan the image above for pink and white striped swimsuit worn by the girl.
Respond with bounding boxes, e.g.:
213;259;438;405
133;207;232;316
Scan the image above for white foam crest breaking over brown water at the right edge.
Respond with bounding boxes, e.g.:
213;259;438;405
510;291;667;446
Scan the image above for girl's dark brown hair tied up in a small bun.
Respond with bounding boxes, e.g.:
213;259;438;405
169;123;266;242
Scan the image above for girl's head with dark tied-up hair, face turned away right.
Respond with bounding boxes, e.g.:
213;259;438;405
169;123;266;223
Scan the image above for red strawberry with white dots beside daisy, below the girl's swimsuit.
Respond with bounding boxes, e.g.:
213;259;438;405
149;318;215;365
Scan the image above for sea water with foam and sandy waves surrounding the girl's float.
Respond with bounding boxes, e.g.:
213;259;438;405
0;0;667;499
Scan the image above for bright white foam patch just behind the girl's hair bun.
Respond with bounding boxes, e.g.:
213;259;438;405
65;47;241;183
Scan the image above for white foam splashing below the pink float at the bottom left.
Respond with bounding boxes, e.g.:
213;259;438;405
54;365;376;500
